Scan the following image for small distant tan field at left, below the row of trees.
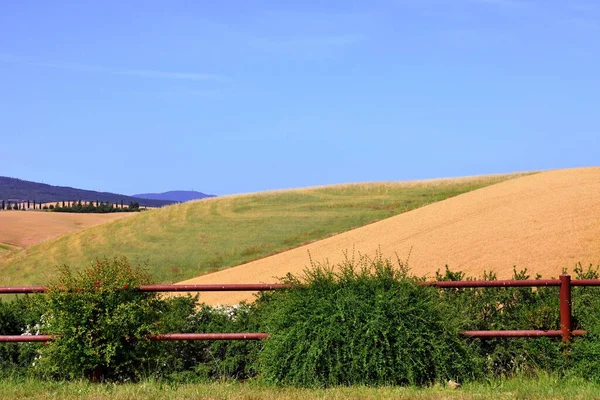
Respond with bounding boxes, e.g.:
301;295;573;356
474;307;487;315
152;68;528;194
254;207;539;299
0;211;130;247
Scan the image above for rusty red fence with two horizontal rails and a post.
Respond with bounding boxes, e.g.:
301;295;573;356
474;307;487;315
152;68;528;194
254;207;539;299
0;275;600;342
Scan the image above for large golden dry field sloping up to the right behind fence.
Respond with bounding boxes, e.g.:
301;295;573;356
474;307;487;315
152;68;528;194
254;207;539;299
180;167;600;304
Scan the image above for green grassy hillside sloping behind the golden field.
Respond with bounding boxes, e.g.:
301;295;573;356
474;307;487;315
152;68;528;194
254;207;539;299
0;174;522;285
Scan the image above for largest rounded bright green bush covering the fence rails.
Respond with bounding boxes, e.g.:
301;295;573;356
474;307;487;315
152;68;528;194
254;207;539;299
258;256;480;387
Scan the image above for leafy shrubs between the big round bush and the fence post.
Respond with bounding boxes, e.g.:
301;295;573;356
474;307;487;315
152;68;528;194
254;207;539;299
436;267;565;376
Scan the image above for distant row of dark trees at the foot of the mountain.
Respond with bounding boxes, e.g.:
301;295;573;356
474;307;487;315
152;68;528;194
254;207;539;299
0;200;141;213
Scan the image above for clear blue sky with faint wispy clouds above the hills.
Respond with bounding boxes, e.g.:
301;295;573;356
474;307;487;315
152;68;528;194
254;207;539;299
0;0;600;195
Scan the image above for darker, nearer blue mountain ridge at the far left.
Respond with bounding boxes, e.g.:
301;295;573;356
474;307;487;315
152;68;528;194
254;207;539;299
0;176;175;207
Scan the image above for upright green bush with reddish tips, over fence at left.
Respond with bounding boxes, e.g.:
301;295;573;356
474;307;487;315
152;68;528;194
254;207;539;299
38;258;160;381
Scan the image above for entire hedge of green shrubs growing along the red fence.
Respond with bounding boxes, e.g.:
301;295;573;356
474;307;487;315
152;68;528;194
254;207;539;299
0;256;600;387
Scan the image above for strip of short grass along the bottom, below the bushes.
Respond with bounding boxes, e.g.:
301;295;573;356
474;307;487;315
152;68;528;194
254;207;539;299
0;375;600;400
